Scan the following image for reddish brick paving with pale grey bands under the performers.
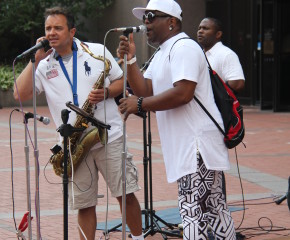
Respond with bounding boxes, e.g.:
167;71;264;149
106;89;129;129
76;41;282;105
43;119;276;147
0;107;290;240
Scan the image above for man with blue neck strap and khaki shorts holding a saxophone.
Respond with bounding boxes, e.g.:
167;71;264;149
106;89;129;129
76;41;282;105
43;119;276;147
14;7;144;240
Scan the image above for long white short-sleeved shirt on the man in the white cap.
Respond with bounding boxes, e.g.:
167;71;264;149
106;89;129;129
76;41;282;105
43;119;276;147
144;33;229;182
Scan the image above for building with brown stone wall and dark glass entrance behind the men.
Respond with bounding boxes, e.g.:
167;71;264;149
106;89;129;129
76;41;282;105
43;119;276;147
87;0;290;111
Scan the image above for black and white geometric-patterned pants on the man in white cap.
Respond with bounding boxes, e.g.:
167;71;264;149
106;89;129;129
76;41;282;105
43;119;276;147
177;154;236;240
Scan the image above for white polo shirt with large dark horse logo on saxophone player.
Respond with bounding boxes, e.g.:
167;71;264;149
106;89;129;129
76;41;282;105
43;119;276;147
35;39;123;148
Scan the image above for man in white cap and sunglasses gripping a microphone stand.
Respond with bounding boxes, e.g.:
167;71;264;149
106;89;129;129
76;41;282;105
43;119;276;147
119;0;236;240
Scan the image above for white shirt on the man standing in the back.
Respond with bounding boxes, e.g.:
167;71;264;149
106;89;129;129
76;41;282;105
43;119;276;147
206;42;245;82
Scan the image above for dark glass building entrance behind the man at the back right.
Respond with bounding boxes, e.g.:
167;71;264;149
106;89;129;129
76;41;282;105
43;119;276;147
206;0;290;111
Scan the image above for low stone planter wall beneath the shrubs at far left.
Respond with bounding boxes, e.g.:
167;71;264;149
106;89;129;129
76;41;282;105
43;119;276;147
0;89;47;108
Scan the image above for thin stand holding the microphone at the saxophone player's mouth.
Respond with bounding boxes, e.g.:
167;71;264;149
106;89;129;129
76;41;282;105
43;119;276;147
30;52;41;240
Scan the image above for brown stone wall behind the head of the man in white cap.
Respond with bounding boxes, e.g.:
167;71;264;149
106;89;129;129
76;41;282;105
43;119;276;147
79;0;205;66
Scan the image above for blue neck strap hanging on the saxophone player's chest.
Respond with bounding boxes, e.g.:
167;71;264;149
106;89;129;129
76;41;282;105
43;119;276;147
58;42;79;106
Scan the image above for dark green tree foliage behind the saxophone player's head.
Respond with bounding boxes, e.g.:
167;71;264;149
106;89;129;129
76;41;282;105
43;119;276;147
0;0;113;61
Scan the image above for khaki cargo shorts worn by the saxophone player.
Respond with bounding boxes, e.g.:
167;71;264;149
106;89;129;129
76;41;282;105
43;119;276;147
68;137;140;209
